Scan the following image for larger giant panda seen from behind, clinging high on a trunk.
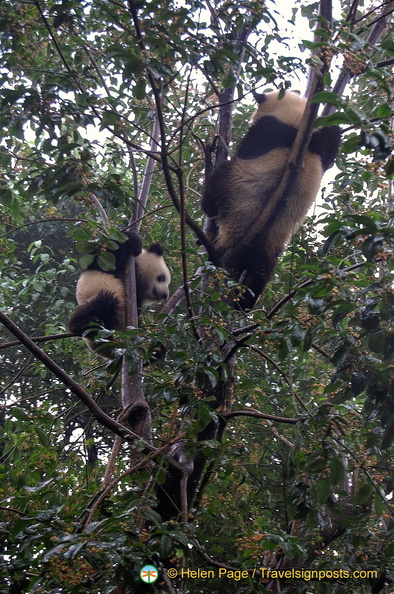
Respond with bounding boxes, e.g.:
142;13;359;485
201;91;341;309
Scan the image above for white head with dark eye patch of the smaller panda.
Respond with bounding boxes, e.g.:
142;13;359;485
136;250;171;305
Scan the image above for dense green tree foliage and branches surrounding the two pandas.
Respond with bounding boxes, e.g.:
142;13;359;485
0;0;394;594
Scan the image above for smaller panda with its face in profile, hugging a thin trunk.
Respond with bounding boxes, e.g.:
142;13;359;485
68;231;171;358
